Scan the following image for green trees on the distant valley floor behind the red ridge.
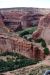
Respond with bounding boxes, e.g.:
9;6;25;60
19;27;36;41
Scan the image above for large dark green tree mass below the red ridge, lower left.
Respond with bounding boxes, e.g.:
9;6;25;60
0;52;38;72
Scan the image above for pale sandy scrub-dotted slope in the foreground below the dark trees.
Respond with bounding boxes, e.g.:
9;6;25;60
0;55;50;75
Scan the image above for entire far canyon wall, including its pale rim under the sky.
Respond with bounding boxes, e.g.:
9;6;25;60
0;8;44;31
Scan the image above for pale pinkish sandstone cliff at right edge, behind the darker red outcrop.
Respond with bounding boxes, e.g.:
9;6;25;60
39;14;50;45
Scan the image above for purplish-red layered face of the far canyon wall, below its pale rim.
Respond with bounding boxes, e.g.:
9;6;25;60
1;11;42;31
